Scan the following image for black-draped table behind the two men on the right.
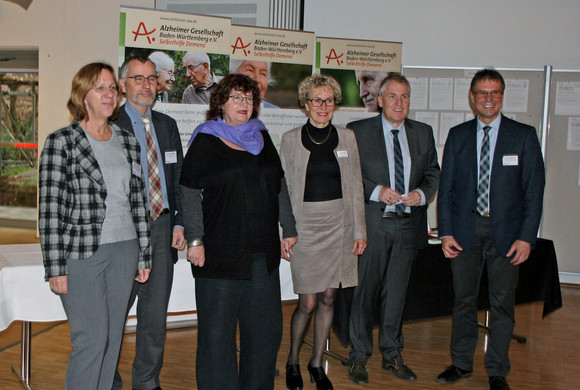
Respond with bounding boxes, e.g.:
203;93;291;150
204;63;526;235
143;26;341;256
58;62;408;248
333;238;562;345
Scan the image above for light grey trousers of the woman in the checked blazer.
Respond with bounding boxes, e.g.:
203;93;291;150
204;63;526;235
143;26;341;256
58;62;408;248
61;239;139;390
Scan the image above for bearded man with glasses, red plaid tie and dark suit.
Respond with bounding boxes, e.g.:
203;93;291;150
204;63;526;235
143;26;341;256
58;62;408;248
113;58;185;390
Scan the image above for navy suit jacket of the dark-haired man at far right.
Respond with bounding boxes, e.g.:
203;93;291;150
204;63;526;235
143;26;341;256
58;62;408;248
437;116;545;256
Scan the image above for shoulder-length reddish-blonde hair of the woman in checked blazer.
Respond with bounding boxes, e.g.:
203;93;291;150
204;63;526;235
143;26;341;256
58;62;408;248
66;62;123;121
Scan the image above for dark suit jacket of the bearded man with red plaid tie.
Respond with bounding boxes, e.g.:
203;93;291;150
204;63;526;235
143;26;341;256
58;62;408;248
113;103;183;262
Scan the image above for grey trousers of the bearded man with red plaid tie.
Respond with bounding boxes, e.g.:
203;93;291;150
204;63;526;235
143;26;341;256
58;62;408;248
113;214;174;390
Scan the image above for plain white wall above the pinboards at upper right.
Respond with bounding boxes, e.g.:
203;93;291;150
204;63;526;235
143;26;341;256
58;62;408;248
304;0;580;69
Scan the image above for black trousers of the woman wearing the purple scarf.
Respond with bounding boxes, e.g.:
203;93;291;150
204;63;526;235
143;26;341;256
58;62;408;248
195;254;282;390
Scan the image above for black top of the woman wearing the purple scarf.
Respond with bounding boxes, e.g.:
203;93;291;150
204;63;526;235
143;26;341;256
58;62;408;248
180;131;294;279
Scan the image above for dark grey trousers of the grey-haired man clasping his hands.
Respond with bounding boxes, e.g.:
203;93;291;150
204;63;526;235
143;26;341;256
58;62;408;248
349;218;418;361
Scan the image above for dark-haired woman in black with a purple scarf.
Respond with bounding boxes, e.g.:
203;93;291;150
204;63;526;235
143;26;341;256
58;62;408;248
181;74;297;390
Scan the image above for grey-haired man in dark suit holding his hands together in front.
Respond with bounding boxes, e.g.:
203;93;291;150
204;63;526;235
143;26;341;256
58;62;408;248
347;73;439;384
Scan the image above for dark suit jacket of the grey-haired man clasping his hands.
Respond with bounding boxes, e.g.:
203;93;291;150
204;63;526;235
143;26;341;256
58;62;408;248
346;114;439;248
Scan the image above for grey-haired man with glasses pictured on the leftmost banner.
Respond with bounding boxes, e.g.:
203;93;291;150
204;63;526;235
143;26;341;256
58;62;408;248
181;51;222;104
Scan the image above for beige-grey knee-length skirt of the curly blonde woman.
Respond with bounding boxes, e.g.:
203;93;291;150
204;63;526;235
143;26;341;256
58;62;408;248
290;199;358;294
